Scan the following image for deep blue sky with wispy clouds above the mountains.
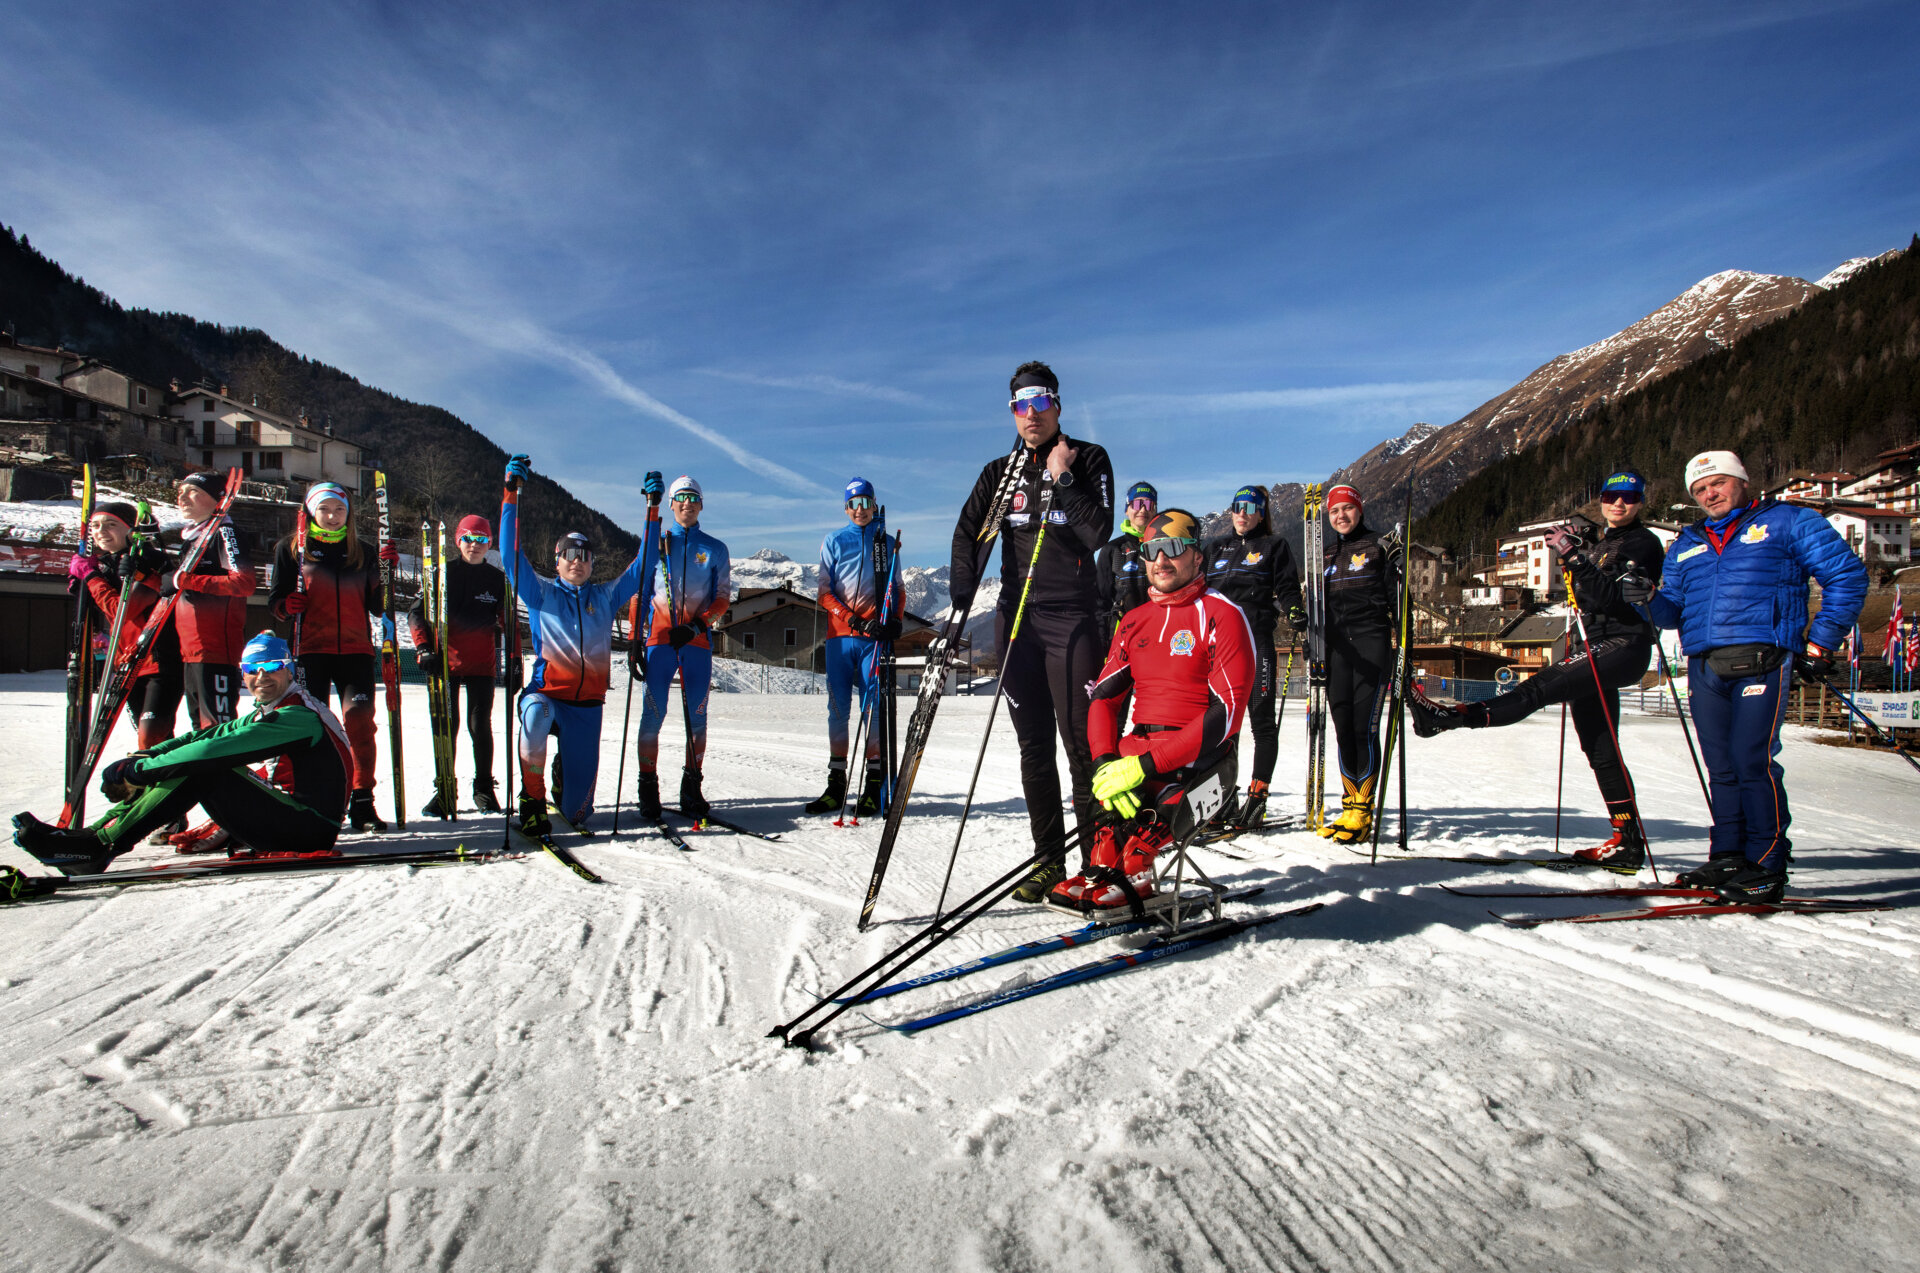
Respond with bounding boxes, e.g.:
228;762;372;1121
0;0;1920;564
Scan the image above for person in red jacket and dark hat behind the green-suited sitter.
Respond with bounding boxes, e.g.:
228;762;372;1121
161;468;259;730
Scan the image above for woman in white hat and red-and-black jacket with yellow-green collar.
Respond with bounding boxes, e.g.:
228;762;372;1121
267;482;397;831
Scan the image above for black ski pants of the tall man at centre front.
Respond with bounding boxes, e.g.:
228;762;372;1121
995;603;1104;858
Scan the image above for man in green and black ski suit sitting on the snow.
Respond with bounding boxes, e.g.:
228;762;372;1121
13;632;353;876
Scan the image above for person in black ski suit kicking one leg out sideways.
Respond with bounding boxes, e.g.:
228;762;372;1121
1409;468;1667;868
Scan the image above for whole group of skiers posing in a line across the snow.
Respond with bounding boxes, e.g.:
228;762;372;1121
3;363;1866;908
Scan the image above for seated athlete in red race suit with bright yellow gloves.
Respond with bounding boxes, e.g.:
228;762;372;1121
1052;509;1256;910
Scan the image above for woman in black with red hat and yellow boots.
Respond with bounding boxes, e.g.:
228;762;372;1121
1321;486;1400;845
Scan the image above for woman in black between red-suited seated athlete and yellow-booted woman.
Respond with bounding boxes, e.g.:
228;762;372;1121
1206;486;1306;826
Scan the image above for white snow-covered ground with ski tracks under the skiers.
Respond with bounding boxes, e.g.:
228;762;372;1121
0;676;1920;1271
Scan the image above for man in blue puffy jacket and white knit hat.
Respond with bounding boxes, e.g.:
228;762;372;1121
1620;451;1866;902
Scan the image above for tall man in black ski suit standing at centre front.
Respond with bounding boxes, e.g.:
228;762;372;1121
950;363;1114;902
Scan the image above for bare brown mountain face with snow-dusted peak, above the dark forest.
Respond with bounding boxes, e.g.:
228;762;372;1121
1328;253;1891;526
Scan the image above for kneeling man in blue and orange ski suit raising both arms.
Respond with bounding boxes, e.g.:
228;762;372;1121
499;455;660;839
